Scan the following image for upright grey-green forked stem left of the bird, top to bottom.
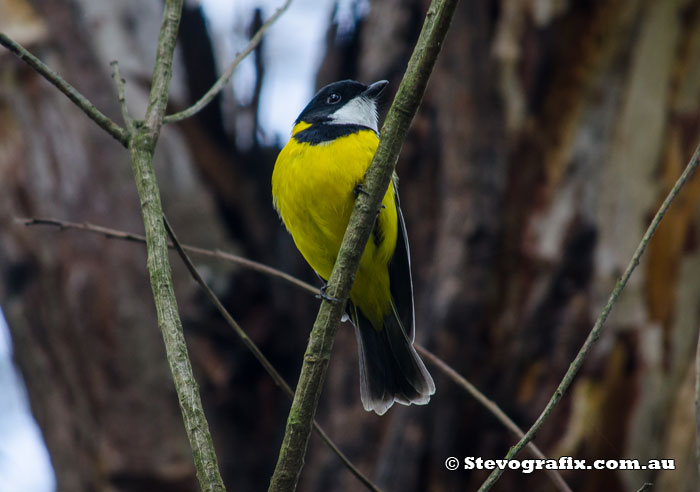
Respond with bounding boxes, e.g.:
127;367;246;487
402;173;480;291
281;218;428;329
129;0;225;492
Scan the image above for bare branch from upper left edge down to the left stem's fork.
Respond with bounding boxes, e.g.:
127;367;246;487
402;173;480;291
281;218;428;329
0;32;129;147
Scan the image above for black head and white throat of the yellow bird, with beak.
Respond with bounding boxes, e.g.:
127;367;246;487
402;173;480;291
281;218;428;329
294;80;388;132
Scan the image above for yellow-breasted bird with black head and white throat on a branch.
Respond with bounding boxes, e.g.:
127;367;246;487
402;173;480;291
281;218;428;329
272;80;435;415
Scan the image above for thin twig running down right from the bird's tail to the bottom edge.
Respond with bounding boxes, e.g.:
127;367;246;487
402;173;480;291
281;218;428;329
414;344;572;492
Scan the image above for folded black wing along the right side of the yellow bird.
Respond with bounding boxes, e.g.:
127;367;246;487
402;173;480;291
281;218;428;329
389;180;415;341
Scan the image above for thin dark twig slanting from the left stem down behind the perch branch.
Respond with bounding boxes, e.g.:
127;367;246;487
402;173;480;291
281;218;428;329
163;216;380;492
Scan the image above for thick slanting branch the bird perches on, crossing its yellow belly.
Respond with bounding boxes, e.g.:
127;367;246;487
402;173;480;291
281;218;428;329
269;0;457;492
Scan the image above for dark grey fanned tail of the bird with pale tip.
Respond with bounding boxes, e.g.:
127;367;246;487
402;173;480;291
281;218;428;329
349;303;435;415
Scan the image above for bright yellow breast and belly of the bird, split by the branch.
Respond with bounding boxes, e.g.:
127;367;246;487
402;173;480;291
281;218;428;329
272;130;397;329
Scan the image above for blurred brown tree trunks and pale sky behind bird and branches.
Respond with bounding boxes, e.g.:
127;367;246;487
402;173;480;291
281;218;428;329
0;0;700;492
